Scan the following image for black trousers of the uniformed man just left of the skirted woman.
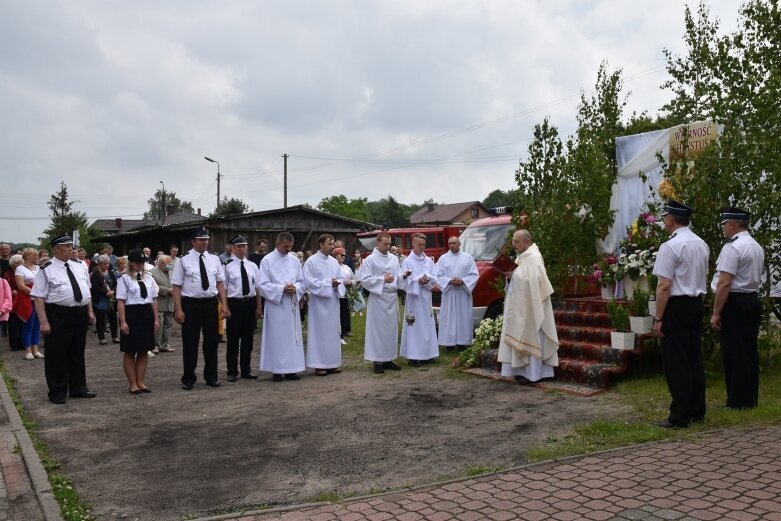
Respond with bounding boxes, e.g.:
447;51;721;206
43;304;89;400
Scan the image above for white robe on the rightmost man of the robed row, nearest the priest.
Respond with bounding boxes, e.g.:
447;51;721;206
436;251;480;346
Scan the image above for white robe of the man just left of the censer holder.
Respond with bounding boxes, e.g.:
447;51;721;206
360;248;399;362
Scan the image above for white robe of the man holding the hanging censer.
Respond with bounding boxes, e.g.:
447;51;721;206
399;253;439;360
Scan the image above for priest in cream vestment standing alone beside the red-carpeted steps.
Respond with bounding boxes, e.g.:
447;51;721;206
498;230;559;384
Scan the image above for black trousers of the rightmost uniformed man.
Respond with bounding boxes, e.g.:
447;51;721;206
719;292;762;409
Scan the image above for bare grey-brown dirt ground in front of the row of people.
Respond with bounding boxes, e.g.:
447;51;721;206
3;320;626;521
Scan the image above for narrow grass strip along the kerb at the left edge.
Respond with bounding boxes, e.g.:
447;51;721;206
0;359;95;521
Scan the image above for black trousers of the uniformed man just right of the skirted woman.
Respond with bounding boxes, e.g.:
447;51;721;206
182;297;219;385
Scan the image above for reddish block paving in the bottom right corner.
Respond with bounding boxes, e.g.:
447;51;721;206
211;427;781;521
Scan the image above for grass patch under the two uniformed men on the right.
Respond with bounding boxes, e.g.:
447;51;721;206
526;360;781;462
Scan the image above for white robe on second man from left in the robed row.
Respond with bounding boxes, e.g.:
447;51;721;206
304;251;342;369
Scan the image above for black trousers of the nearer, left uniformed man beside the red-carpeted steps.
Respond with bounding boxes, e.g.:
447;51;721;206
662;297;705;427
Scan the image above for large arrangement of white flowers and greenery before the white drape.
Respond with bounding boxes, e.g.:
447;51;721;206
618;212;667;280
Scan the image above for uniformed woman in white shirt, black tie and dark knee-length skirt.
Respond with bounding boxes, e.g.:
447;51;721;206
116;250;160;394
